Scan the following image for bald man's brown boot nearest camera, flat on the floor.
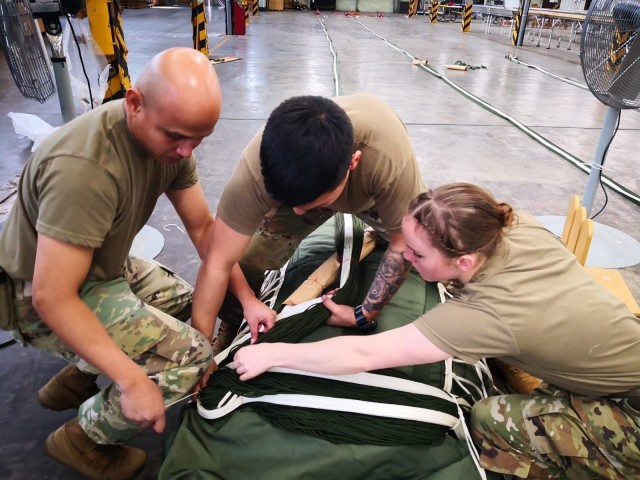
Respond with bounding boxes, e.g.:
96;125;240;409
45;418;147;480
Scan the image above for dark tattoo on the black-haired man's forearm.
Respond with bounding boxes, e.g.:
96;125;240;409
362;247;411;315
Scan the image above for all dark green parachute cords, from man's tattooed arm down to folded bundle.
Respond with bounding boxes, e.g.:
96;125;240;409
198;215;457;445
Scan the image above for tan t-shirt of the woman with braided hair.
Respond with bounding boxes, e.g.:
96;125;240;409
414;214;640;396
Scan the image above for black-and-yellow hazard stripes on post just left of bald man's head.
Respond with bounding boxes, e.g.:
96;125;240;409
103;0;131;102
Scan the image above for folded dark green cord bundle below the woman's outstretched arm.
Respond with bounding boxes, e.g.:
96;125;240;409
200;368;458;446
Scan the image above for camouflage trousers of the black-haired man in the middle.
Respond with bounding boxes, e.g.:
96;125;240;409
219;207;387;326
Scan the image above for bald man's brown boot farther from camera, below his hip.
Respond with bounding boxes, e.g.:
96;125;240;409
36;363;100;412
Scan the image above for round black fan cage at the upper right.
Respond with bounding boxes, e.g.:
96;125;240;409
580;0;640;109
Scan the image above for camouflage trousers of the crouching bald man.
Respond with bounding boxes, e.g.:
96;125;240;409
12;257;212;444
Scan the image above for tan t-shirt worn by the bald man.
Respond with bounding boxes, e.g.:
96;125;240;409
0;100;198;280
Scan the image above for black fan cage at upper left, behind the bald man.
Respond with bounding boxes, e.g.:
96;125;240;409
0;0;55;103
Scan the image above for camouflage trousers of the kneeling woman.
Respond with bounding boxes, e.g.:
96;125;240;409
471;385;640;480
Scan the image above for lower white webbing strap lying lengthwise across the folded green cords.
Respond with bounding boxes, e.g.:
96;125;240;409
198;393;460;429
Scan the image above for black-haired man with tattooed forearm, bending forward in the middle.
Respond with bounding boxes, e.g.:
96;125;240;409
192;94;426;354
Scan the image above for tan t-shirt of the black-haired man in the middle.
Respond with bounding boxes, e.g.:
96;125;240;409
217;94;426;235
